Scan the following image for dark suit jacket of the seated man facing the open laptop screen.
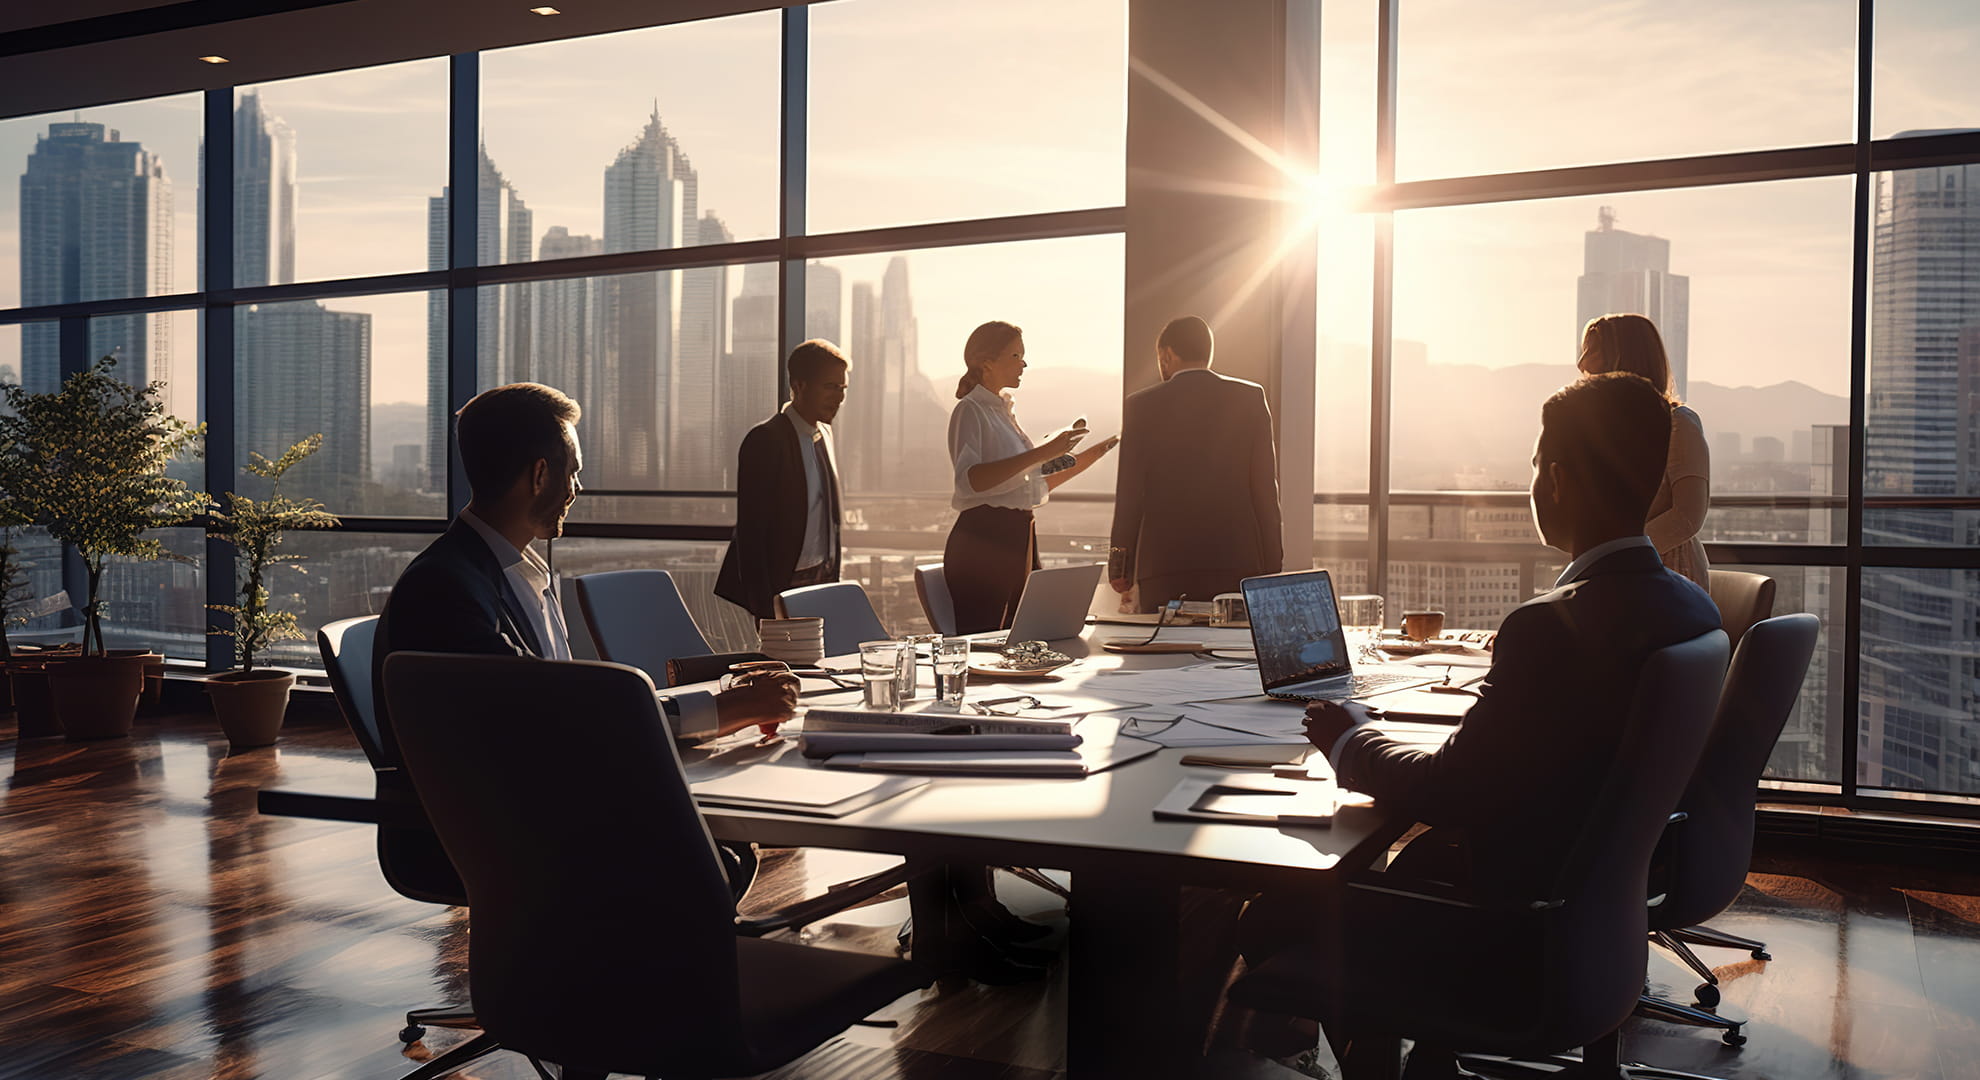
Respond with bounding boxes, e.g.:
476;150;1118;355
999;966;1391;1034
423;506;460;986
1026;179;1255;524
1333;545;1719;900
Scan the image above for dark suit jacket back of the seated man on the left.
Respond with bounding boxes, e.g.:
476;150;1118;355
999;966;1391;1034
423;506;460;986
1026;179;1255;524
372;517;543;765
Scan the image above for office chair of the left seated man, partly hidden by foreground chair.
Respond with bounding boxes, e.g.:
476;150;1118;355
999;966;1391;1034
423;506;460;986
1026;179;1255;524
317;614;493;1080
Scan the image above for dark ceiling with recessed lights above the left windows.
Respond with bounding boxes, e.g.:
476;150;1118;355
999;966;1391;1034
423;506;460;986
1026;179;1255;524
0;0;784;117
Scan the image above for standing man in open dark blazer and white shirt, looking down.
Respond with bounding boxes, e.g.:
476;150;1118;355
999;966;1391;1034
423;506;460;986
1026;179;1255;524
715;337;851;618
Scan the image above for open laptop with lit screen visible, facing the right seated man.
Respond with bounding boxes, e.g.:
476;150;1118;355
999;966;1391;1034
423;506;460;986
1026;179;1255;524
1238;571;1437;702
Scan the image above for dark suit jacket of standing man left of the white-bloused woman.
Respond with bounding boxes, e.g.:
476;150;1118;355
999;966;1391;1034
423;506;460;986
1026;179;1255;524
715;412;840;618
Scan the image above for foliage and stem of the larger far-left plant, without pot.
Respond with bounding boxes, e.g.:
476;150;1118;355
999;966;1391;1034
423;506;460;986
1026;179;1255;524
0;357;212;656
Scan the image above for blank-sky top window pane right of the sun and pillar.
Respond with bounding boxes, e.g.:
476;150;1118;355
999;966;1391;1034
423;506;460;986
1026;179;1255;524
1396;0;1857;180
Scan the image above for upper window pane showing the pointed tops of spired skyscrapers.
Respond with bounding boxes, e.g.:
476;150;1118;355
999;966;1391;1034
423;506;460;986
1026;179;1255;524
475;12;782;264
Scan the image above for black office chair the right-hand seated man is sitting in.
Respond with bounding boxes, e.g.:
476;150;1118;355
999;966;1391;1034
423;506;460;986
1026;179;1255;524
1230;630;1727;1074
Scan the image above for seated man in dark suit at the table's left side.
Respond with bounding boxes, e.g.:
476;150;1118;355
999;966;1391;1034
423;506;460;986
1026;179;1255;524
372;382;798;761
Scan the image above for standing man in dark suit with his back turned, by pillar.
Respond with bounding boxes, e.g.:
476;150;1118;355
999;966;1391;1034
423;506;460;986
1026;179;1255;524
1107;315;1285;610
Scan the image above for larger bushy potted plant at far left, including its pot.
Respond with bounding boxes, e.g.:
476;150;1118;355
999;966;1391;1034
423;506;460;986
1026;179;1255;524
0;357;210;739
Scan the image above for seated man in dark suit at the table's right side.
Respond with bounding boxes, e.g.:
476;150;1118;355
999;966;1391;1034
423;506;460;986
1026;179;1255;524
1239;373;1719;1076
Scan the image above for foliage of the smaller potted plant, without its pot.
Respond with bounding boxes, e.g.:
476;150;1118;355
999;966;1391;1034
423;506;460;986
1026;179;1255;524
206;434;339;672
